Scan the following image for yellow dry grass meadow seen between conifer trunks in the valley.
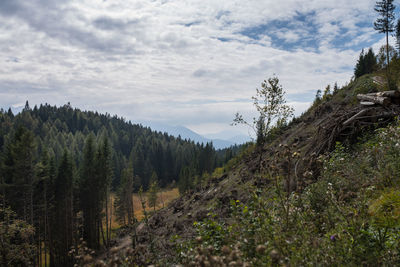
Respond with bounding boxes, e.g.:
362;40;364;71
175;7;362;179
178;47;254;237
111;188;179;229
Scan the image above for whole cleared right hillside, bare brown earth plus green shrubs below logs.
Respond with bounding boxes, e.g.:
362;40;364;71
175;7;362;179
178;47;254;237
97;75;400;266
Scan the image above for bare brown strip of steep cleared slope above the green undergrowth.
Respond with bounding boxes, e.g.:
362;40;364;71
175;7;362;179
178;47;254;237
113;76;400;266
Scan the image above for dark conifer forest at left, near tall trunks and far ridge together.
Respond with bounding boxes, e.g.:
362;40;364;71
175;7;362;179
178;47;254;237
0;101;238;266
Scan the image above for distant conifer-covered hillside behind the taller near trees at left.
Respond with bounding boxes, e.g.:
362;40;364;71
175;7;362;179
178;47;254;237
0;103;238;190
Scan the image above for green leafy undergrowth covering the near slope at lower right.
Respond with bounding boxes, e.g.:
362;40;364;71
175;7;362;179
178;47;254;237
181;123;400;266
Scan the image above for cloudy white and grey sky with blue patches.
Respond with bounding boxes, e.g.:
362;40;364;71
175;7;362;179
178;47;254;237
0;0;392;134
